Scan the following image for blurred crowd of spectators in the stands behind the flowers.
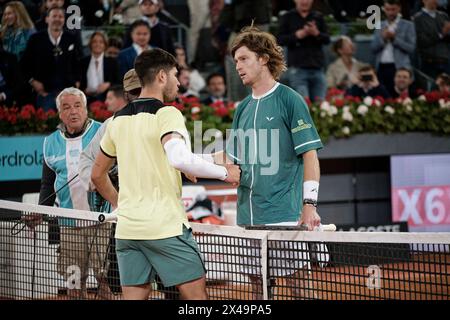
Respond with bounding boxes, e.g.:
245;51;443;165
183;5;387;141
0;0;450;110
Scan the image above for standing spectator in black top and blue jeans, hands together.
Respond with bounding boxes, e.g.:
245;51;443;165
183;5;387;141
278;0;330;100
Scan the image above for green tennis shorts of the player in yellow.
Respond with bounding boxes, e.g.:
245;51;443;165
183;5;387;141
116;227;206;287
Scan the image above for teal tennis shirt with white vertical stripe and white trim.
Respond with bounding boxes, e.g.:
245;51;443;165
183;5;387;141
225;83;323;225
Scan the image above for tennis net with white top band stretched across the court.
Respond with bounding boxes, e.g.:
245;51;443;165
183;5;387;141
0;200;450;300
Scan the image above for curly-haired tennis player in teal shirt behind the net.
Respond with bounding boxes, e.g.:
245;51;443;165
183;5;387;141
213;27;323;298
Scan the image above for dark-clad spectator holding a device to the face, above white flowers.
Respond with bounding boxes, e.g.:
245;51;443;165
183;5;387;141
346;65;390;99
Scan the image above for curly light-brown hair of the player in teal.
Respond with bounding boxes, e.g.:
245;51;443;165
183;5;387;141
231;26;287;80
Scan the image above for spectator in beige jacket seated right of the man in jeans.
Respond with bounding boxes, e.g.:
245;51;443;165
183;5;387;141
327;36;363;90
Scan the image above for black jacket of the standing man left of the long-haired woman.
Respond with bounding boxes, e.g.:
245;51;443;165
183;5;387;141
21;30;81;92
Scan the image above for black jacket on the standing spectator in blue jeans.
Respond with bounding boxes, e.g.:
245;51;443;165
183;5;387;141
278;9;330;69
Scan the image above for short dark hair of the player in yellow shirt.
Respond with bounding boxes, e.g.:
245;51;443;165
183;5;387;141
134;48;178;86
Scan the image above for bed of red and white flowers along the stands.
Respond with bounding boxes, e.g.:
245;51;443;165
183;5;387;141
0;89;450;141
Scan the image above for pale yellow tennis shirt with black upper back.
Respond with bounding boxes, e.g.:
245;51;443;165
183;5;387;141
100;99;189;240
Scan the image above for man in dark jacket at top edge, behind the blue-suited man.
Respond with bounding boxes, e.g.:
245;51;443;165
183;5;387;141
139;0;175;54
